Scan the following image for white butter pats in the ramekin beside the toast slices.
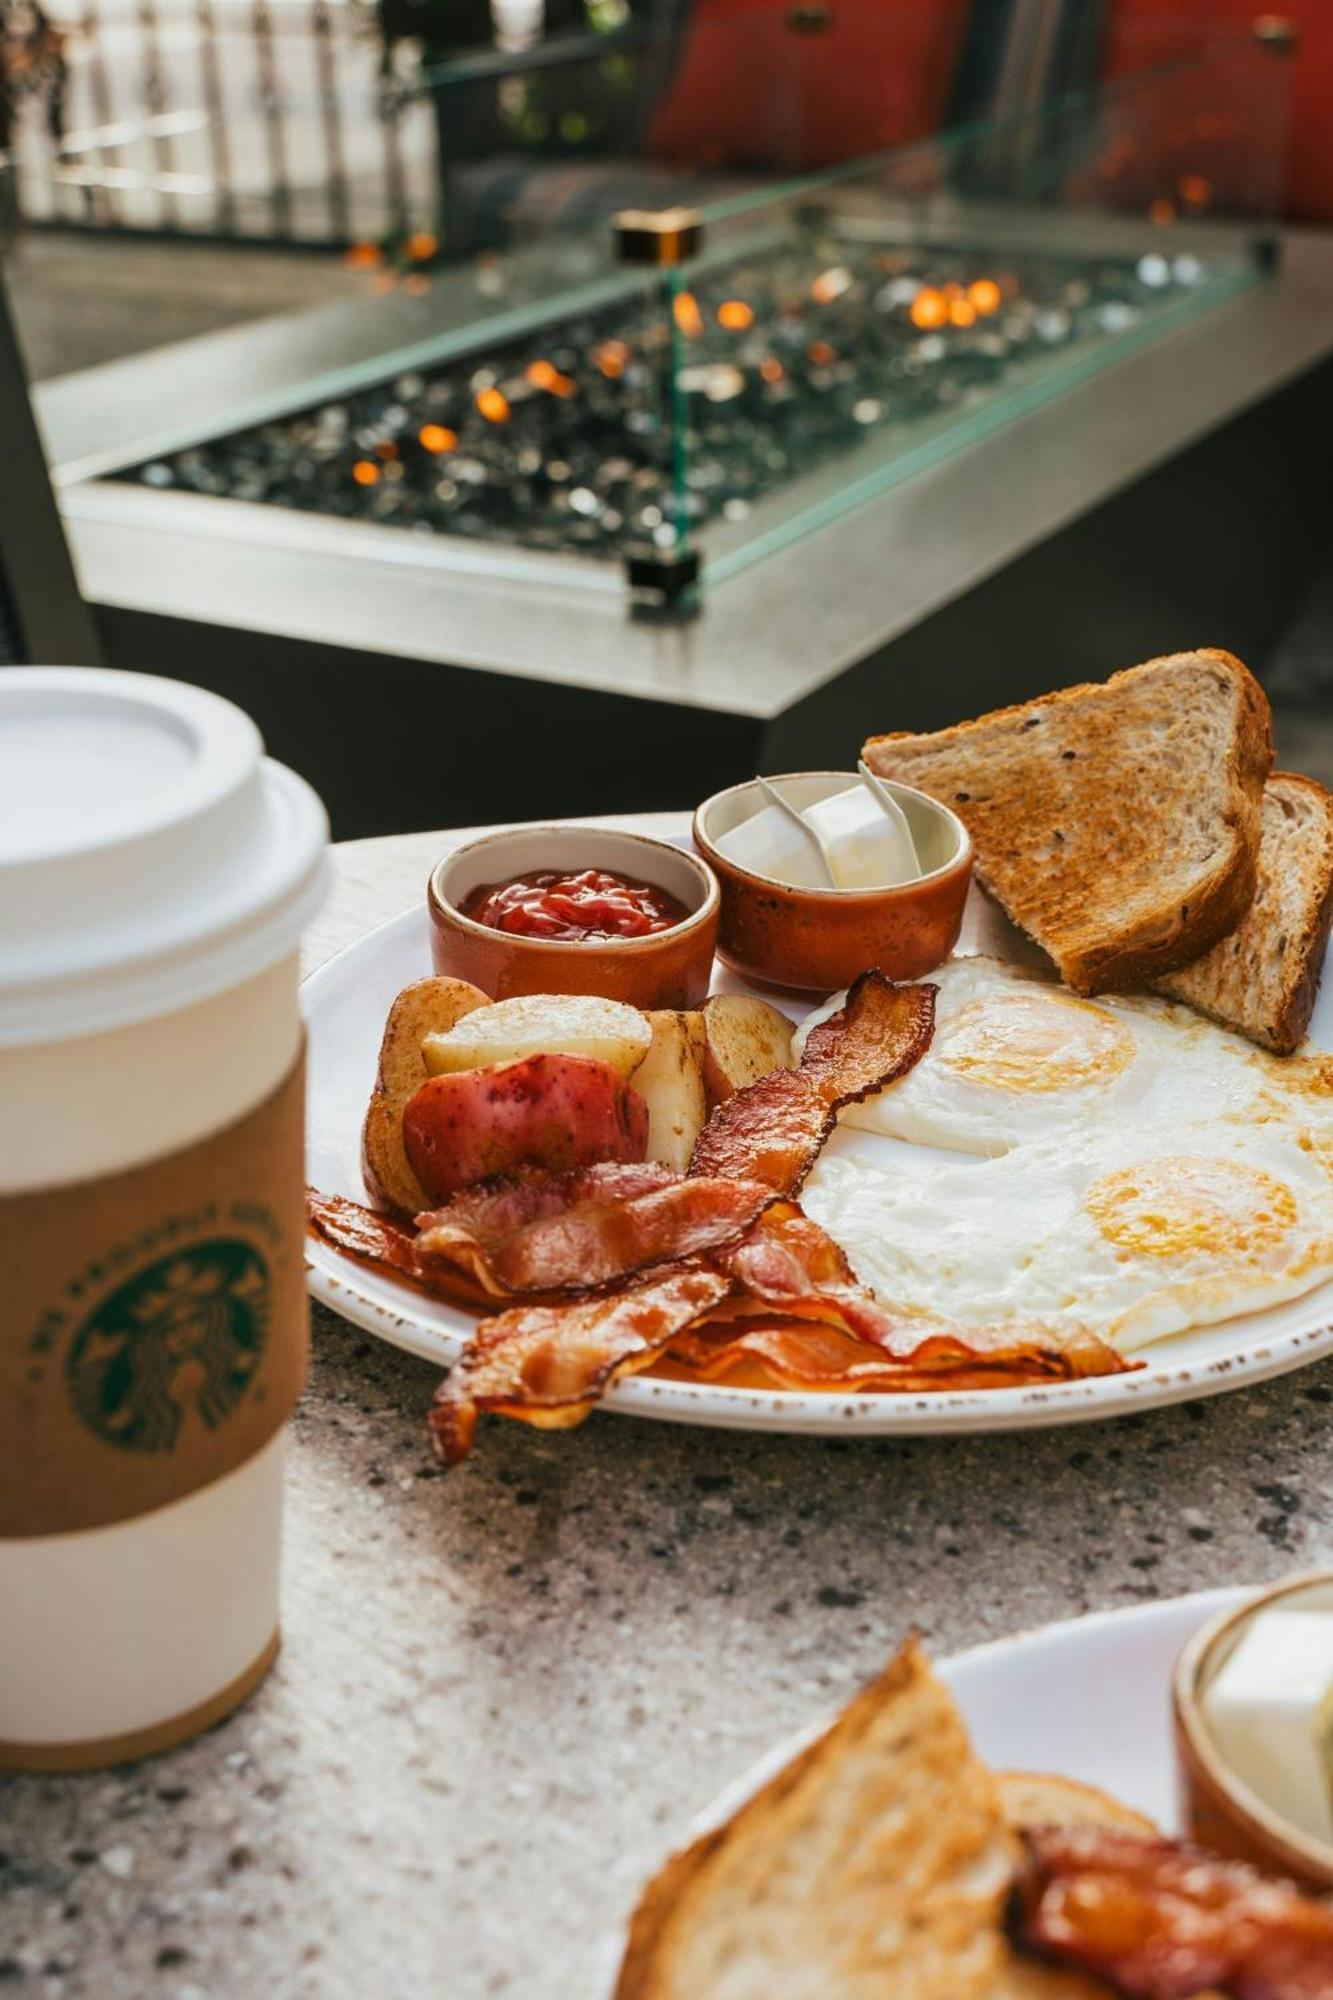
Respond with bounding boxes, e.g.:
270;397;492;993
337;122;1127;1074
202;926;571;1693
717;784;921;888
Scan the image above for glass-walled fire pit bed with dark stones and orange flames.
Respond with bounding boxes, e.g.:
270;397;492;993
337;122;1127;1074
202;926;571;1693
120;38;1285;592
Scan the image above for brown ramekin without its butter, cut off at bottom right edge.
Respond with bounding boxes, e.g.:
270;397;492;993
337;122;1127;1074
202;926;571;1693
1171;1570;1333;1894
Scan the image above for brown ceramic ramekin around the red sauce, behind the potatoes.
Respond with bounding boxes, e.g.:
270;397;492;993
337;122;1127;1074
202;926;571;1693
426;826;719;1008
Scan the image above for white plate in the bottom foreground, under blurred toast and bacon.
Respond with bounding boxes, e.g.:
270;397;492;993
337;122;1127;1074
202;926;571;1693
606;1590;1251;1994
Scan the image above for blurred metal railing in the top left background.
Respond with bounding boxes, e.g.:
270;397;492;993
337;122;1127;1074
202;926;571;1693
0;0;438;244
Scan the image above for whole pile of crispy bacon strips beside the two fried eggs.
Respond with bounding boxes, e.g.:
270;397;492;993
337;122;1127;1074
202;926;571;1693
308;972;1131;1464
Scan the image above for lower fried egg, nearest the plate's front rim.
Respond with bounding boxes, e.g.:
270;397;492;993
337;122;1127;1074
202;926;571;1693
801;1124;1333;1352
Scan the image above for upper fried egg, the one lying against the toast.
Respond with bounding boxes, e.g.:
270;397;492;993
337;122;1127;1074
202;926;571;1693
803;958;1333;1154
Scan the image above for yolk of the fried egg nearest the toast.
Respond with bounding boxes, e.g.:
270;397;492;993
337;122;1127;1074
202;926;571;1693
939;992;1135;1092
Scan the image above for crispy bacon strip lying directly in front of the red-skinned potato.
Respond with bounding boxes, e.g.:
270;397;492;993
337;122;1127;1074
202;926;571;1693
416;1166;773;1300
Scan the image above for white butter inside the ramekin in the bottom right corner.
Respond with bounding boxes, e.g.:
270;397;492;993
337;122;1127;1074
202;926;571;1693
1203;1610;1333;1840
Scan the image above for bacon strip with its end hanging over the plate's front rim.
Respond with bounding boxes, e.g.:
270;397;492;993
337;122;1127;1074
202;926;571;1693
430;1264;731;1466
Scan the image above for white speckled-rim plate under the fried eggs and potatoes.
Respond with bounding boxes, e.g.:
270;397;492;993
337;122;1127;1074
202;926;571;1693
304;820;1333;1434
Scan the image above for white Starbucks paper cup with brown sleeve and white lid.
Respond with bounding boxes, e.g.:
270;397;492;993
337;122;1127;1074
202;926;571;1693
0;668;328;1768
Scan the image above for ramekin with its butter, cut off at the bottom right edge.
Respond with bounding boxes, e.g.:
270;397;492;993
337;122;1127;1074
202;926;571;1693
1173;1570;1333;1892
